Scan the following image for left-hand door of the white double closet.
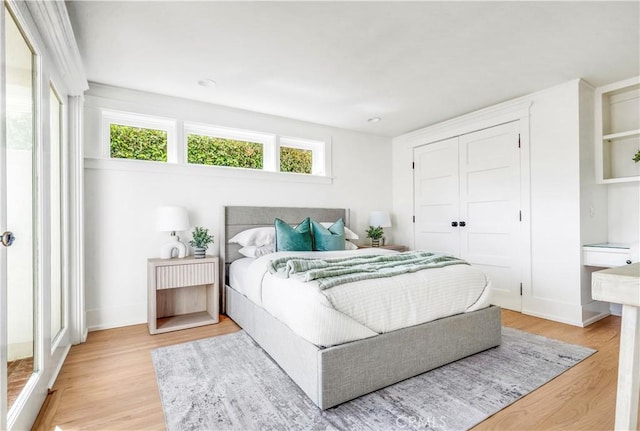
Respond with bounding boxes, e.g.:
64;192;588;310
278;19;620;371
413;138;460;256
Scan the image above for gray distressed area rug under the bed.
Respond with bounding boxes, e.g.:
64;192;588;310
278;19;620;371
151;327;595;431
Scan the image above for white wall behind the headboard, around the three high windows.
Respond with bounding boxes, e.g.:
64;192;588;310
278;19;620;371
85;84;393;330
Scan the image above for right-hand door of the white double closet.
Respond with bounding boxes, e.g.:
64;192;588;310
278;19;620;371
459;121;522;311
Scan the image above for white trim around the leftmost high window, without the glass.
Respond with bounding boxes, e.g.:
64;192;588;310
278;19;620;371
100;110;178;163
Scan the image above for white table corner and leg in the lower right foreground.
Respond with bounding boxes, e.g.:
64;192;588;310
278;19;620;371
591;263;640;431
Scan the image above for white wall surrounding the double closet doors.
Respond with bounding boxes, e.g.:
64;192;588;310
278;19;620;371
393;80;608;325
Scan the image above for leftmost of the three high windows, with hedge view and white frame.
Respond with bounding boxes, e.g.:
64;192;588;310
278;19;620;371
102;111;177;163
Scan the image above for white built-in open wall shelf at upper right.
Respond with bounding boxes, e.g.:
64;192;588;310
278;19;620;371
595;77;640;184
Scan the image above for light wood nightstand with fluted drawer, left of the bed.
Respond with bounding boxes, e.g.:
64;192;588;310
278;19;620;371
147;256;220;334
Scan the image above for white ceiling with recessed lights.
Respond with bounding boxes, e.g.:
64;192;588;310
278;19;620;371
67;1;640;136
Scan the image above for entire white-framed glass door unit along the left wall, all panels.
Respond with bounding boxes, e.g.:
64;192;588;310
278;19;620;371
0;2;69;429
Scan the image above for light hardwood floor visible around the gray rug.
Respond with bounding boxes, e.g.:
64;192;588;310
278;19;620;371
34;311;620;431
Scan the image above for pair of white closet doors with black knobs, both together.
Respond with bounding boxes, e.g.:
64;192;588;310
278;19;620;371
413;121;522;311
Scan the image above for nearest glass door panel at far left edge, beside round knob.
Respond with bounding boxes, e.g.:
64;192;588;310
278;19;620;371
3;6;41;426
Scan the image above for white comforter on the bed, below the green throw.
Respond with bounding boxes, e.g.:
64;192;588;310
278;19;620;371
230;248;490;346
